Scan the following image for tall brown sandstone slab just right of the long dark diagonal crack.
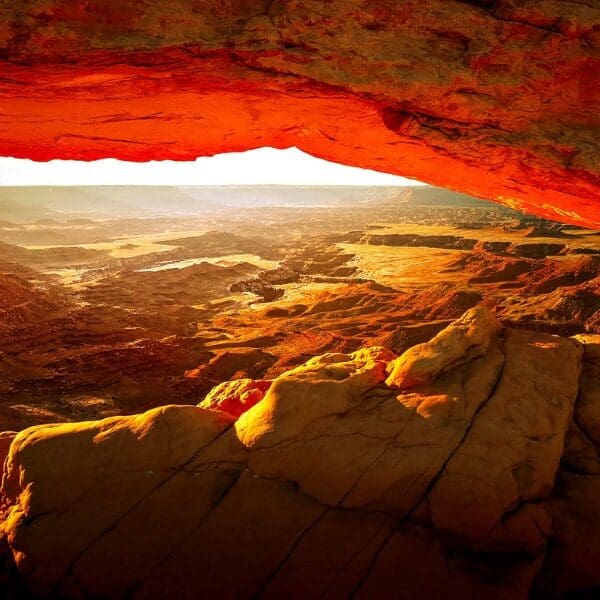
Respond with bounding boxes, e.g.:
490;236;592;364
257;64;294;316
429;331;581;552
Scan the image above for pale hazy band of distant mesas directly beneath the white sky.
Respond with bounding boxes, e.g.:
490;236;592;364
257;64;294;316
0;184;490;223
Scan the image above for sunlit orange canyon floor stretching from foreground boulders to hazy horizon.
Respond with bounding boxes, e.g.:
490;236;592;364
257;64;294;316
0;188;600;430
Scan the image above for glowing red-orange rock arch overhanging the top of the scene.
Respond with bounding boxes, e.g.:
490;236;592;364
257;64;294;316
0;0;600;228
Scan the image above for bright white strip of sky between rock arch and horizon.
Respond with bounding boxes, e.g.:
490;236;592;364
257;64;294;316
0;148;423;185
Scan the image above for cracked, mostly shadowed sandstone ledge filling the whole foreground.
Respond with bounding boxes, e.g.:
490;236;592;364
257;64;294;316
2;312;600;600
